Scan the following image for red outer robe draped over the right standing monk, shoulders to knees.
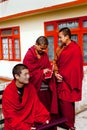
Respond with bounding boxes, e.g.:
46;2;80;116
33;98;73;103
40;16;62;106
56;41;83;102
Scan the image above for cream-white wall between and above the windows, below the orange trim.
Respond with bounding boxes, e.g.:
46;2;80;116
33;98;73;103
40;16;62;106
0;6;87;77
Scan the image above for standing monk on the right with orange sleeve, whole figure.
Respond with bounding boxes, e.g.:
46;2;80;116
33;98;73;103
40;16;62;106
54;27;83;130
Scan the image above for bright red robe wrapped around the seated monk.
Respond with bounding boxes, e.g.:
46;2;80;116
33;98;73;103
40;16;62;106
2;80;50;130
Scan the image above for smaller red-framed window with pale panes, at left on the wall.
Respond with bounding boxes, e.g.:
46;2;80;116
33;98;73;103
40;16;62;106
0;27;21;61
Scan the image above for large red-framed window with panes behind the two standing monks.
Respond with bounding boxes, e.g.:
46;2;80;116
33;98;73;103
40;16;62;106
44;16;87;65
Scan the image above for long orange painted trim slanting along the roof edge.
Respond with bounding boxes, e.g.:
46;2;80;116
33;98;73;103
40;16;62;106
0;0;87;22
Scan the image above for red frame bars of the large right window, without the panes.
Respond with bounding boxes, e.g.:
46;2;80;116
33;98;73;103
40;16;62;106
44;16;87;66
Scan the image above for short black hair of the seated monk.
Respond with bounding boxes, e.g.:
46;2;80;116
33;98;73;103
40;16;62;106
12;63;28;79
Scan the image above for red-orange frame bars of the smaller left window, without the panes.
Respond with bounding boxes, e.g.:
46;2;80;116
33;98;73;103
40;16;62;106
0;26;21;61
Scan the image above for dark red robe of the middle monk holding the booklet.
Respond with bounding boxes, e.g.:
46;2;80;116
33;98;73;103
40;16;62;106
23;46;58;114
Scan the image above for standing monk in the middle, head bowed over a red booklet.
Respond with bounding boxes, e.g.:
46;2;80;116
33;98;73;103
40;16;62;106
23;36;57;119
